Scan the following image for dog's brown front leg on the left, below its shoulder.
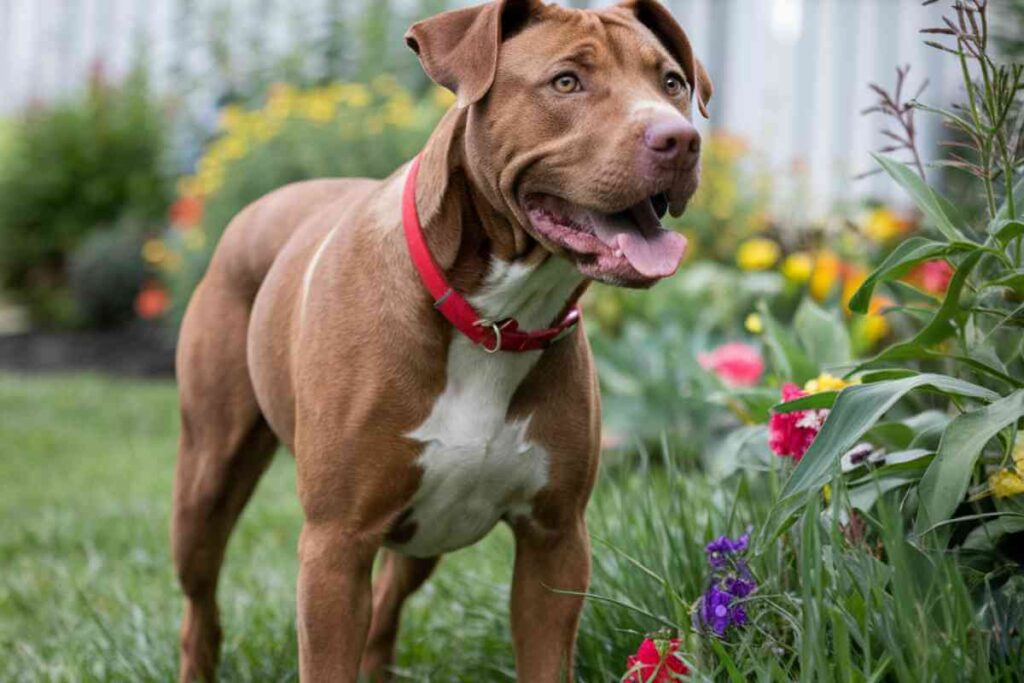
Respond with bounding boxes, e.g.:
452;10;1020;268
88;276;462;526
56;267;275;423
297;522;380;683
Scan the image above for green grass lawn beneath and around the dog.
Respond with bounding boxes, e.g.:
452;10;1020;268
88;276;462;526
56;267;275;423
0;375;1024;683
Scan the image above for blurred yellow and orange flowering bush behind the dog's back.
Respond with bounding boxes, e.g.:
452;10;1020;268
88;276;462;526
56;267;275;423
150;76;453;319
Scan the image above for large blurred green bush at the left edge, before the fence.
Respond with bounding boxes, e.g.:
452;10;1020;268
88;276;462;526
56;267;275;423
0;70;171;322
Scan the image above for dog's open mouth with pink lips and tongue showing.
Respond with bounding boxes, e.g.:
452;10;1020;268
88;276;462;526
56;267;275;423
523;193;686;287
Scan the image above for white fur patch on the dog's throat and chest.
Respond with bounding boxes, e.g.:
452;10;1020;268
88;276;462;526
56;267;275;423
388;258;580;557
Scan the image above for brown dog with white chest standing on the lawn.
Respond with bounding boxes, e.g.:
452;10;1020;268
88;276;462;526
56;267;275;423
172;0;712;683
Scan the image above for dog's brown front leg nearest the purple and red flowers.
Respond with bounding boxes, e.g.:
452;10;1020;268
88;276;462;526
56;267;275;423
511;511;590;683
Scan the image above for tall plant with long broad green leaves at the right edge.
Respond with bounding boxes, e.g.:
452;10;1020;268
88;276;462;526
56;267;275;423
761;0;1024;561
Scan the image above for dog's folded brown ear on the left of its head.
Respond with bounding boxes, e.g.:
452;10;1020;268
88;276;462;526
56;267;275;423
406;0;543;108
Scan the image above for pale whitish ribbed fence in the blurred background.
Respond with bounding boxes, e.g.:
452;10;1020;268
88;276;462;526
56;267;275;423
0;0;956;210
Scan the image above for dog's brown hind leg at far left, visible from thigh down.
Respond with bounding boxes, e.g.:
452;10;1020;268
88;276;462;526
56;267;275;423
171;285;278;681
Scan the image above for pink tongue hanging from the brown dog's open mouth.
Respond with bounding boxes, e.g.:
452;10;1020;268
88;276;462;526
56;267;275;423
591;202;686;278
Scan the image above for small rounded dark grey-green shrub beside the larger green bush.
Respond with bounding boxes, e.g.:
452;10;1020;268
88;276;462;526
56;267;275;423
68;228;146;328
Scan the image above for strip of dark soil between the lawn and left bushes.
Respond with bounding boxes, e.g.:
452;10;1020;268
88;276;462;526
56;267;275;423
0;323;176;377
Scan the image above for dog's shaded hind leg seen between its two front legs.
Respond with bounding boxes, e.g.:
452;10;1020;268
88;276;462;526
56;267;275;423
360;550;439;683
